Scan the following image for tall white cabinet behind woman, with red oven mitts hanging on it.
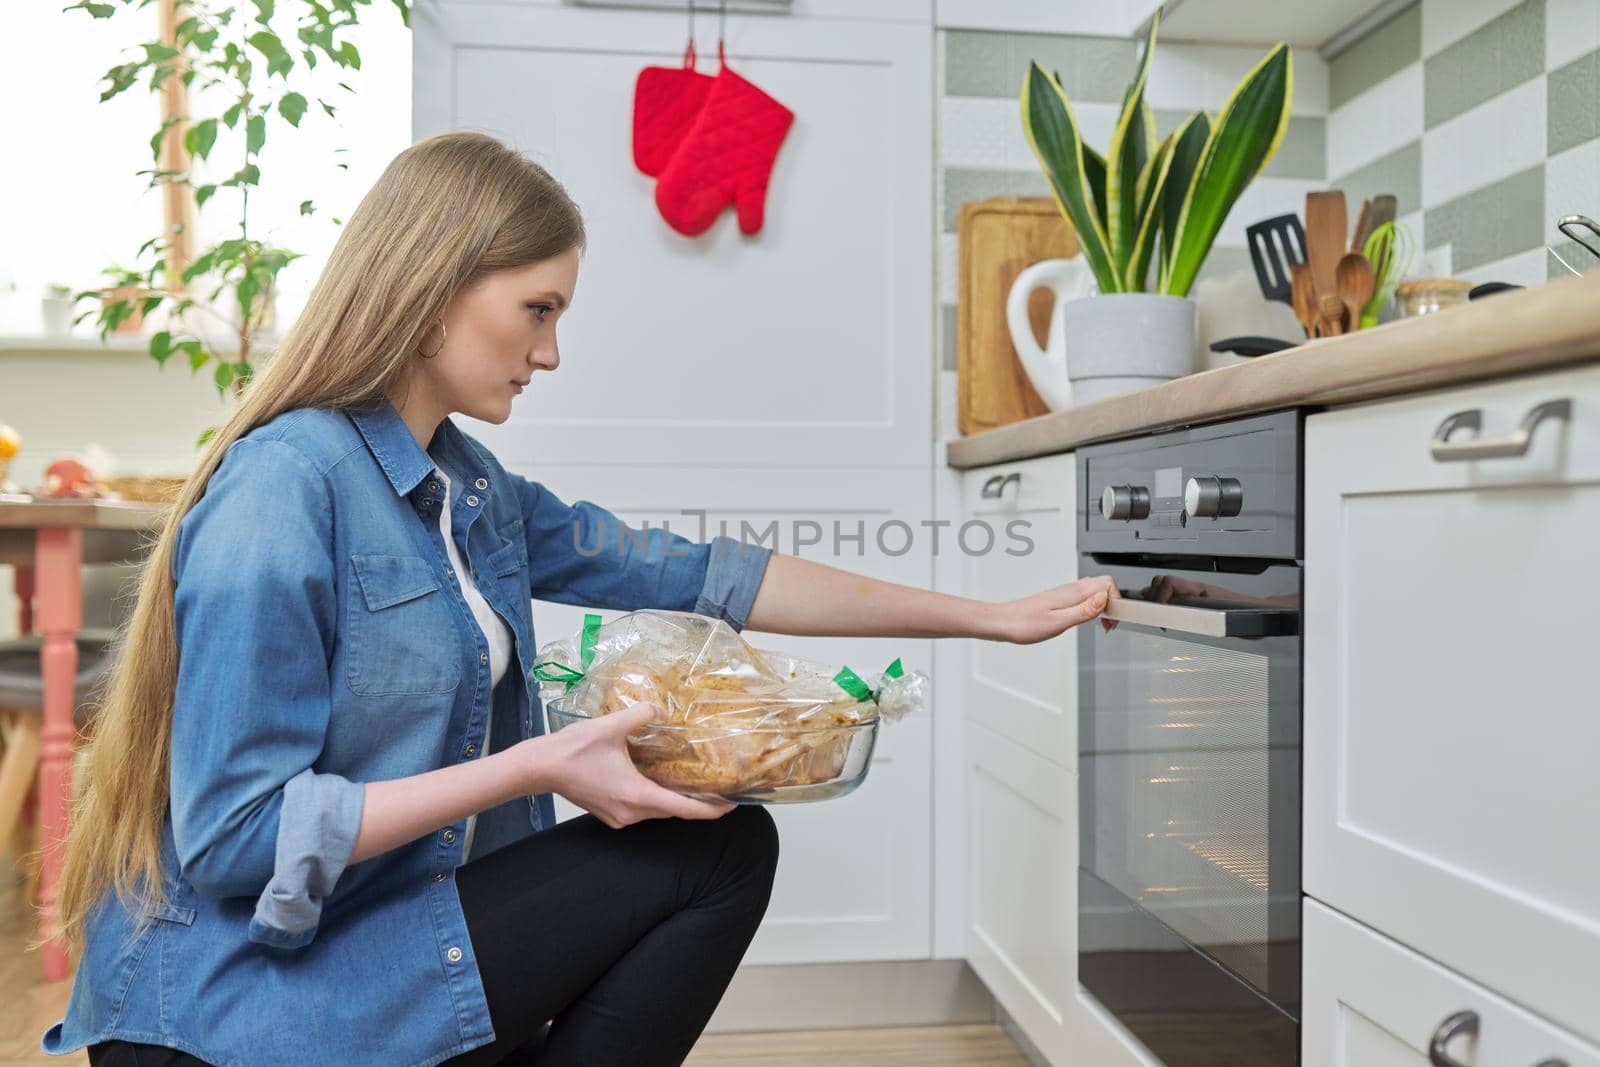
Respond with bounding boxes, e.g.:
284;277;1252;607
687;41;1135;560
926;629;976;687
413;0;934;963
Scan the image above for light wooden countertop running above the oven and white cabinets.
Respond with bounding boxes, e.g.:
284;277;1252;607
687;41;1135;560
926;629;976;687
946;272;1600;469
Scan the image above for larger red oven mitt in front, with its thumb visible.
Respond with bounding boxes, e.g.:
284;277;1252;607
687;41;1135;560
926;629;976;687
656;66;795;237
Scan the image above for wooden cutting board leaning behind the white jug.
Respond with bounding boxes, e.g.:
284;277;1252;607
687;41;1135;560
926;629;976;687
955;197;1078;434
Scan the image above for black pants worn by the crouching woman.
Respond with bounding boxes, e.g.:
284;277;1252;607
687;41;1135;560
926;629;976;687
88;806;778;1067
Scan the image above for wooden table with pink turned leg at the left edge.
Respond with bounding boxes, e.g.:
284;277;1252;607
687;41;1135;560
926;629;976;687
0;501;166;981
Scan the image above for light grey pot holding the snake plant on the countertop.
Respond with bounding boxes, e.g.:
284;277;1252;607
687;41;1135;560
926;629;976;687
1061;293;1195;405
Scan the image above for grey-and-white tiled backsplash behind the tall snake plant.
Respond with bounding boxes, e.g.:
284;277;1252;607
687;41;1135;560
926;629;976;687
938;30;1328;371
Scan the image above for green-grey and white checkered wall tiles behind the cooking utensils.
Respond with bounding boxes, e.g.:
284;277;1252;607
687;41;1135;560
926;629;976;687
1328;0;1600;285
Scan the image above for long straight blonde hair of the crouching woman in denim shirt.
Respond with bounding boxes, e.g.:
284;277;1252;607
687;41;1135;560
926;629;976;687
56;133;584;955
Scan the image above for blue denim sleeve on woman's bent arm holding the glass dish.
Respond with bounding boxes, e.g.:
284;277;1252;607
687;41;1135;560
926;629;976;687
171;438;363;949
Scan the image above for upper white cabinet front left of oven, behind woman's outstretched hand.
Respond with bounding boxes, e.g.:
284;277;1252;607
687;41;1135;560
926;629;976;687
950;454;1078;768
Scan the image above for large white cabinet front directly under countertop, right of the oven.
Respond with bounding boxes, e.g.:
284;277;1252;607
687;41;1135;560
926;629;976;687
1304;366;1600;1049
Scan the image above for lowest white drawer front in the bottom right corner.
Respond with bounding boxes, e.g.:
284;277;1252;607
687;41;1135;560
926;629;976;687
1301;901;1600;1067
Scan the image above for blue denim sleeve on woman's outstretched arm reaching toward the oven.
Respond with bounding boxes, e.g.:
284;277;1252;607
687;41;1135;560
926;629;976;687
509;475;773;630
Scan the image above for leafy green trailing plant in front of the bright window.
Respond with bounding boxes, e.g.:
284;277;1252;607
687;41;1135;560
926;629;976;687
62;0;410;435
